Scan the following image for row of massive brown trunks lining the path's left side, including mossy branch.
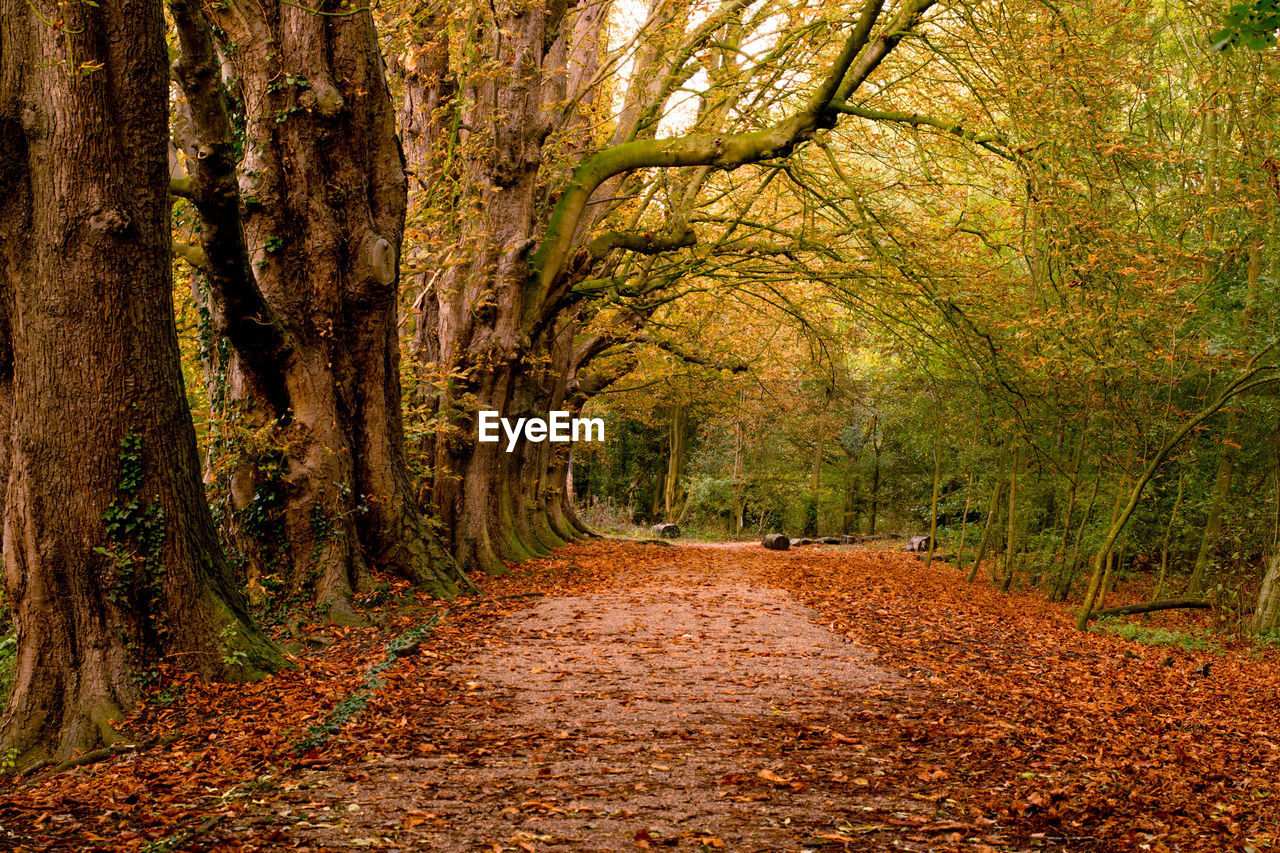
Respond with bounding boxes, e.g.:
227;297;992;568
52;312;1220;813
0;0;932;763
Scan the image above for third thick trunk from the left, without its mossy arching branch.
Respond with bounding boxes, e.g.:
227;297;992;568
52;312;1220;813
402;4;607;571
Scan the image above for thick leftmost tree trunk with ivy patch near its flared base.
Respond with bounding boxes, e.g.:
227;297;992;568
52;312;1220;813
0;0;283;763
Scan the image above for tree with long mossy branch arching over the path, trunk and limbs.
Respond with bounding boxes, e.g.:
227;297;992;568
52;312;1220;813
404;0;933;570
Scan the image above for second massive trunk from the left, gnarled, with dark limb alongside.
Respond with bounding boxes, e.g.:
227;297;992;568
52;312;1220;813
172;0;465;621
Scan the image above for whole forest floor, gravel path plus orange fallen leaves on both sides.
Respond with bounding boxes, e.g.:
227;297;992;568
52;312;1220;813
0;542;1280;853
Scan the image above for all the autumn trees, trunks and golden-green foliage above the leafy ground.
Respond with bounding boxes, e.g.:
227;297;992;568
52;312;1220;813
0;0;1280;766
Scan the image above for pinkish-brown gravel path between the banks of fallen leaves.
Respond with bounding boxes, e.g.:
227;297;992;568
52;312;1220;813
230;549;967;850
